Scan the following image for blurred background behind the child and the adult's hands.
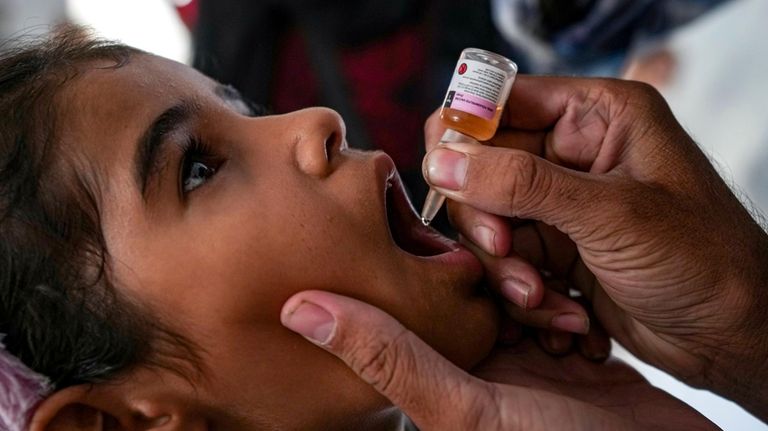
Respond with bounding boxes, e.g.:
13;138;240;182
0;0;768;430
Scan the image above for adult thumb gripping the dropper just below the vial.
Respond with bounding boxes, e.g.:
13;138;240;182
422;143;610;234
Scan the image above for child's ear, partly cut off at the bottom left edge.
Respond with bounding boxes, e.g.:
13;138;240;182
29;384;207;431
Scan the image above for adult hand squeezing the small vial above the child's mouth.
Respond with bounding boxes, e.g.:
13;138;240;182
423;76;768;419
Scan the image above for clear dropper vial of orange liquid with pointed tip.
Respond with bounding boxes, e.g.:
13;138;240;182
421;48;517;225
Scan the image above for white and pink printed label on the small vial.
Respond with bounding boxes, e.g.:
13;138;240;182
443;60;507;120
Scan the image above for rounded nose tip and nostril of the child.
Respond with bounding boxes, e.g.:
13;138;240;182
295;108;345;178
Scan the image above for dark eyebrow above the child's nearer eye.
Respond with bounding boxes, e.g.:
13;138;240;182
134;101;196;200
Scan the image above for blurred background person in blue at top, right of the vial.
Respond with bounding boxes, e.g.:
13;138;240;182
491;0;726;87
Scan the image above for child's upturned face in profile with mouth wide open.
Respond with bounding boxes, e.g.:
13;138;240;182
58;55;496;429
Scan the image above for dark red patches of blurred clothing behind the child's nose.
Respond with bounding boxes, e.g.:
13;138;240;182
273;27;426;170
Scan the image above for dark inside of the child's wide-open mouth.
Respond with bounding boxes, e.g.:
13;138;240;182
384;171;458;257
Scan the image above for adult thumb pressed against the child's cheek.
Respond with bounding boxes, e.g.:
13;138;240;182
280;291;499;430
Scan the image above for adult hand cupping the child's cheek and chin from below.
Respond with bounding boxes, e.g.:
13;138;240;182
281;291;715;431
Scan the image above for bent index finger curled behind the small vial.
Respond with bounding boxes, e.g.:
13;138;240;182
492;76;652;173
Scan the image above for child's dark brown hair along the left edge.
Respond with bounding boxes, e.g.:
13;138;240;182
0;26;198;389
